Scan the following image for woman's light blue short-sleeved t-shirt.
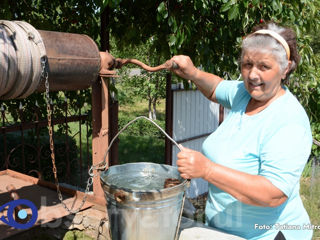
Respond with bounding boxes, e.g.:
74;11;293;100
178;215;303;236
202;81;313;240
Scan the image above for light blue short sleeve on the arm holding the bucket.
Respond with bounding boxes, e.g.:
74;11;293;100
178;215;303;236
259;124;312;197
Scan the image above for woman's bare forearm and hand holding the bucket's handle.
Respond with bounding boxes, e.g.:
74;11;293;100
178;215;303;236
177;148;287;207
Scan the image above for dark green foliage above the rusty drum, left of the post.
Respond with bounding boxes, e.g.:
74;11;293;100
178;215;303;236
0;0;100;39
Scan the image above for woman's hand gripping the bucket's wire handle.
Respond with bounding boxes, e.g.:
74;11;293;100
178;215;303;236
177;145;212;179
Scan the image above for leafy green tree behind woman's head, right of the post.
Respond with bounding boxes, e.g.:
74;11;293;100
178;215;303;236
108;0;320;156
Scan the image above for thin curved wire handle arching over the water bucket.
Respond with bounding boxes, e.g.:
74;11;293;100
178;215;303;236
89;116;182;173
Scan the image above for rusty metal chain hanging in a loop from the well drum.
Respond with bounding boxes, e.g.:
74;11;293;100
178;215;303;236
41;57;94;214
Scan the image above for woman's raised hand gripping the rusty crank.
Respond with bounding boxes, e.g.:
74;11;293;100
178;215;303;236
170;55;198;80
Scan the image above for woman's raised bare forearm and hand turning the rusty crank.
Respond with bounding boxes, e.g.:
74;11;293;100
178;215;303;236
171;55;222;102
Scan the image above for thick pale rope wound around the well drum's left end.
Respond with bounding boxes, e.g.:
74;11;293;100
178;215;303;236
0;20;46;99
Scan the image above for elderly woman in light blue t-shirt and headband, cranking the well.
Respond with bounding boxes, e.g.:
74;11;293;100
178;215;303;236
172;23;312;240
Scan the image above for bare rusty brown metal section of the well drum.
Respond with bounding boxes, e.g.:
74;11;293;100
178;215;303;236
37;30;100;92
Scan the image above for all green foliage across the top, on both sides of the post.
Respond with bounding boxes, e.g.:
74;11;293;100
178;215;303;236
0;0;320;154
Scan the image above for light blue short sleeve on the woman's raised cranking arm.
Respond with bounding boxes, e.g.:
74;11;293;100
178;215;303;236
215;80;244;109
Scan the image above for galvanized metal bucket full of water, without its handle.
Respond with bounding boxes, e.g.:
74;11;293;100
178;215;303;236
100;116;188;240
